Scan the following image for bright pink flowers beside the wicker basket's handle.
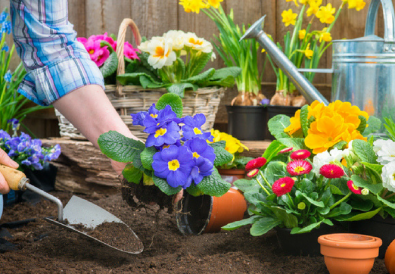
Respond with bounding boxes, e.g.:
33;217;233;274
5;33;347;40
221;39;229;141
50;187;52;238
77;32;139;67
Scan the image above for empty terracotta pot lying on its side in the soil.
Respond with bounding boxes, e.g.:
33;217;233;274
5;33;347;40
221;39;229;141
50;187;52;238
176;188;247;235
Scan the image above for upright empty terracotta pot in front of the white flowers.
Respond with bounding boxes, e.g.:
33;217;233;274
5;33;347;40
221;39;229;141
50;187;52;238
318;233;382;274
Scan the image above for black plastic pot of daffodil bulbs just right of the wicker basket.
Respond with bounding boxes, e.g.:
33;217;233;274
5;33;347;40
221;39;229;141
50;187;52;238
226;106;267;140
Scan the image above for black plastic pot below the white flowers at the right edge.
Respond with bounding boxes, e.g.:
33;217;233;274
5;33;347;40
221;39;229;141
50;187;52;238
349;215;395;259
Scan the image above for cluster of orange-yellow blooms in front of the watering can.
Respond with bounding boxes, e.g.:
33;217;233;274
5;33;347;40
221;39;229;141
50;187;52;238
284;101;369;154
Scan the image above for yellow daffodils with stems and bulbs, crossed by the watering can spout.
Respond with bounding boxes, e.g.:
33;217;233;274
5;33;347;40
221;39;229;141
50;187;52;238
268;0;366;110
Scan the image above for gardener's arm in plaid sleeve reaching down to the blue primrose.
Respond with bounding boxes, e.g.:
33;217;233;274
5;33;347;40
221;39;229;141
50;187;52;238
11;0;139;173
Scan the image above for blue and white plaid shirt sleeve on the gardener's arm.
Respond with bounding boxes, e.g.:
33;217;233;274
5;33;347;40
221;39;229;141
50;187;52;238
11;0;104;106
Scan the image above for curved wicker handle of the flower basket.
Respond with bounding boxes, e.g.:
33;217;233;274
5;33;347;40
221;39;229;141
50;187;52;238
116;18;141;95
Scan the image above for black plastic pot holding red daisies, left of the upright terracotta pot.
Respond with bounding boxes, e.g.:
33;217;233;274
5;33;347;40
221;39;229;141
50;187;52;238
275;224;347;256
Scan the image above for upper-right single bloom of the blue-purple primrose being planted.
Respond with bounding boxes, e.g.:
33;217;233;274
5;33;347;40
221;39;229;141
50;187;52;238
182;113;214;141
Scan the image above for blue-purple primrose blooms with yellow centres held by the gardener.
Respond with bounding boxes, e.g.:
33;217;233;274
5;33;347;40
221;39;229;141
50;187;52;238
132;104;216;189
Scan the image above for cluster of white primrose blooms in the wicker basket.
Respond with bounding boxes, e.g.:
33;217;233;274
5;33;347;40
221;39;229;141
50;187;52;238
138;30;215;69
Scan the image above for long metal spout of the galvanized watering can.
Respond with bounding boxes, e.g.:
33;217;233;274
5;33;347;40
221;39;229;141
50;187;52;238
240;15;328;105
